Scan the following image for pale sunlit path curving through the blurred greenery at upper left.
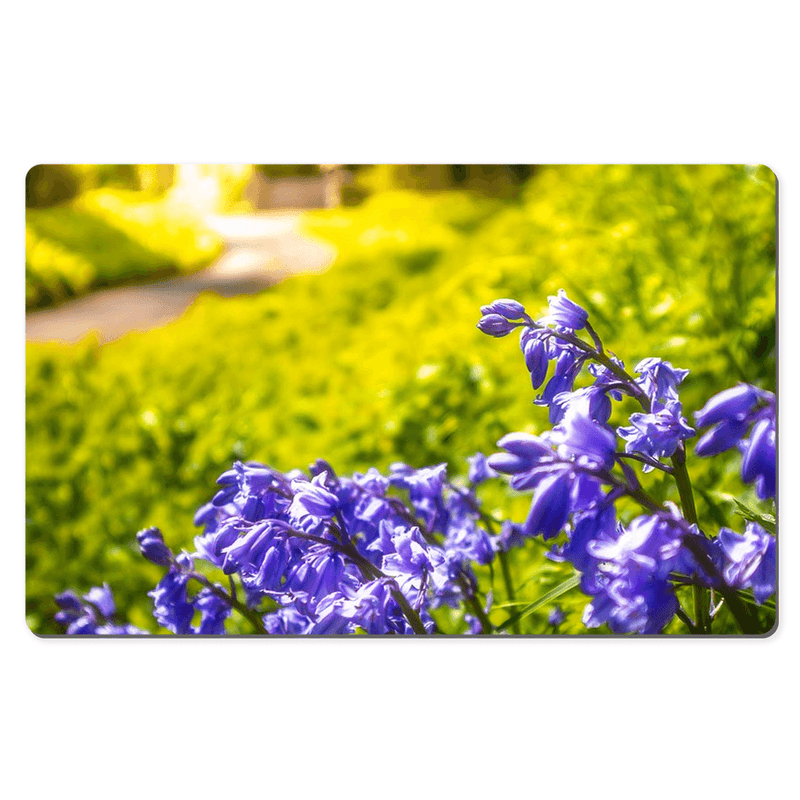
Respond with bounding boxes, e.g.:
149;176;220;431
25;211;336;343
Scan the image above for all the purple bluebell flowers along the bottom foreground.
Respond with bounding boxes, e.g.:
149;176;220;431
56;289;776;635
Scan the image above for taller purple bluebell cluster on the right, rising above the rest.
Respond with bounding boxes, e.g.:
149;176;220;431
478;290;775;633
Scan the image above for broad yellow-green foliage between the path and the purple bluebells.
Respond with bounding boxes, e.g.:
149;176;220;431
26;166;775;633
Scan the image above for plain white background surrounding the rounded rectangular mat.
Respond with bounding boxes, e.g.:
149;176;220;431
0;0;800;800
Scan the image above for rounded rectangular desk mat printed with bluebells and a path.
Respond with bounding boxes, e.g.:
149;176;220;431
25;164;777;638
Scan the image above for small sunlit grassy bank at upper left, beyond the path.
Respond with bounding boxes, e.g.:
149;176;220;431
25;188;222;309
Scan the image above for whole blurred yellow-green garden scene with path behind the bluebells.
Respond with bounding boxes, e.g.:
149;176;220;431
25;164;776;633
